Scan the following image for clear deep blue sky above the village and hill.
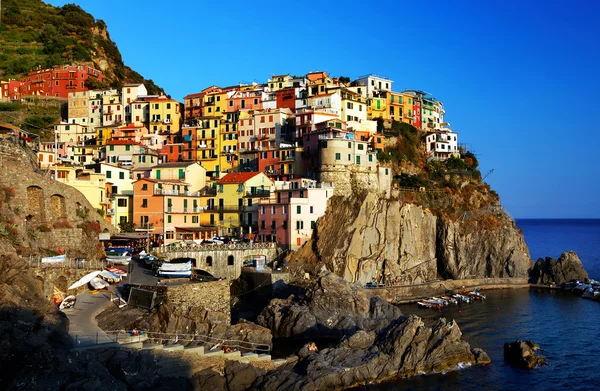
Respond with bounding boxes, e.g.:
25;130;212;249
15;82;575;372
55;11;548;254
47;0;600;218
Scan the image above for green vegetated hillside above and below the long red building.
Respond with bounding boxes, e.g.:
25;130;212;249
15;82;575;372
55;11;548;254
0;0;164;136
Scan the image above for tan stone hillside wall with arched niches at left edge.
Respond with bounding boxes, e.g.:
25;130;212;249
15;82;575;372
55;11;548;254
0;140;115;260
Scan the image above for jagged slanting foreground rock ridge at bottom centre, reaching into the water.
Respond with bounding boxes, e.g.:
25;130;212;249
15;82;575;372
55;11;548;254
253;315;476;390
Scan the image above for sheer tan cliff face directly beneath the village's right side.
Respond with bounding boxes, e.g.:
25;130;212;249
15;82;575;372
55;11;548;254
292;193;532;284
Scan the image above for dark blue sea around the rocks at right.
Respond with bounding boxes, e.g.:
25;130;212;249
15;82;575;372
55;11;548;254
361;219;600;391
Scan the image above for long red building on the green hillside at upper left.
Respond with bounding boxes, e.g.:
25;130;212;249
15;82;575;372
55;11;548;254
19;65;102;98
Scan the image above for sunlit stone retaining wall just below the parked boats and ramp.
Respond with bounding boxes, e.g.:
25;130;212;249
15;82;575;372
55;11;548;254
167;280;231;324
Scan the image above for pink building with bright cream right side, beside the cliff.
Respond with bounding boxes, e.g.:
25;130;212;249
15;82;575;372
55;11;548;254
258;179;333;250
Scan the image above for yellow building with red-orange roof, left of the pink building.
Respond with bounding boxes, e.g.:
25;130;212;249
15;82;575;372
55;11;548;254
214;172;273;236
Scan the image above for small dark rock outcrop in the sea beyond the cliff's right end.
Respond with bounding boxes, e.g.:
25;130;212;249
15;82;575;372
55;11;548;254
530;251;588;285
